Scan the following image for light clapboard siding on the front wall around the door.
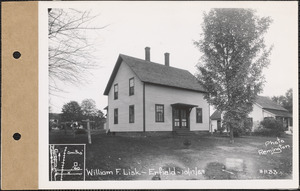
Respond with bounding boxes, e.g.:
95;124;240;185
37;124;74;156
145;84;209;131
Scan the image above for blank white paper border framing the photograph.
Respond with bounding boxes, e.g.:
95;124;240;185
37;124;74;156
39;1;299;189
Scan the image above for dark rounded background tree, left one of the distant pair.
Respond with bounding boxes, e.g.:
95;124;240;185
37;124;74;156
62;101;82;122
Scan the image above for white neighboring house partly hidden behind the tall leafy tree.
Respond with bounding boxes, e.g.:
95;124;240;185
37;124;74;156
210;96;293;131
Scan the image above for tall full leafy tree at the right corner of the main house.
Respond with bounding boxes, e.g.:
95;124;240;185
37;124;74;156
195;9;271;143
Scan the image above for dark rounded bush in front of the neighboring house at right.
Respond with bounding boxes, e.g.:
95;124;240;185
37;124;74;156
255;118;285;137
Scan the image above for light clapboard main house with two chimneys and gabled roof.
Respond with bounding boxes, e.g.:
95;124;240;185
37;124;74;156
104;47;209;132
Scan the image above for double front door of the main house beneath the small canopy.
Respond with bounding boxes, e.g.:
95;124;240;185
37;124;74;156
173;108;189;131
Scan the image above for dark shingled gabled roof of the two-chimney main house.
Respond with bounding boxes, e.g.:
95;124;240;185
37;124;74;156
104;54;206;95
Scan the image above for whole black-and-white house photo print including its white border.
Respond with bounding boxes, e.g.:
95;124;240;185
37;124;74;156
40;1;299;188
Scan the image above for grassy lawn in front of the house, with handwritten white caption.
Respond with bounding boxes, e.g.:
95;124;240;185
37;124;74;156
50;131;292;180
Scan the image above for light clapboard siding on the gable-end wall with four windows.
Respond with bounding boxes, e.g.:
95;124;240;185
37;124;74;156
108;62;143;132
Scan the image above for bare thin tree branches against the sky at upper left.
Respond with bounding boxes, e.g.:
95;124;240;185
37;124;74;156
48;9;105;95
